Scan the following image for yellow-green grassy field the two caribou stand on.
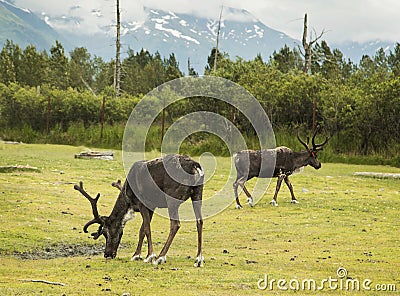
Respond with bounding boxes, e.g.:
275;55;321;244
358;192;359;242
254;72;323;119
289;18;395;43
0;143;400;295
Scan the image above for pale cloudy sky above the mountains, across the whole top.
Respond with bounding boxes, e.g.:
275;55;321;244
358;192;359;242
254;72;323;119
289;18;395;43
13;0;400;43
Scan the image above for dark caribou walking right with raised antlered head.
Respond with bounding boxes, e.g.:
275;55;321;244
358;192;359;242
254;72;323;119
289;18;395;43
233;126;328;209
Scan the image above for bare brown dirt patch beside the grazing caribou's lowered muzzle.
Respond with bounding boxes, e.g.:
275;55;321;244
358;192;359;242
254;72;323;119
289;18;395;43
13;243;117;260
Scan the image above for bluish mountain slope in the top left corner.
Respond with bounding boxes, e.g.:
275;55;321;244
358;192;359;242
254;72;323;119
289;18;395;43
0;0;67;50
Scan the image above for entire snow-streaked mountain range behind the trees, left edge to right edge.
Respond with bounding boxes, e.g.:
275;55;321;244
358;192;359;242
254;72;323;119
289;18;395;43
0;0;393;74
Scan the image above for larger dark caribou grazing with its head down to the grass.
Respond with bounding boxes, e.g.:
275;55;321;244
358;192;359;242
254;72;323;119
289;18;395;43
74;155;204;267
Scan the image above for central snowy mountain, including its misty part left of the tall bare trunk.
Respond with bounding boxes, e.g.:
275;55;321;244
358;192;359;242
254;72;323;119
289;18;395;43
42;7;297;73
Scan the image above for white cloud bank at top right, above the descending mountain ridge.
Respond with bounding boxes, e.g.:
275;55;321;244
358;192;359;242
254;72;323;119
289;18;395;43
249;0;400;42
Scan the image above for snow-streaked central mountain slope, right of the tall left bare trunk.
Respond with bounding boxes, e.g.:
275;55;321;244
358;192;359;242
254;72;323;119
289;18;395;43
123;8;296;70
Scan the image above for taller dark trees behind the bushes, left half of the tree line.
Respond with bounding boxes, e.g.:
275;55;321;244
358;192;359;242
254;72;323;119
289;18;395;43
0;40;182;96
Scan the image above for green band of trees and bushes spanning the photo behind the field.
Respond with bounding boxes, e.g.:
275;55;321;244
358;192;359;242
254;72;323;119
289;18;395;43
0;41;400;165
